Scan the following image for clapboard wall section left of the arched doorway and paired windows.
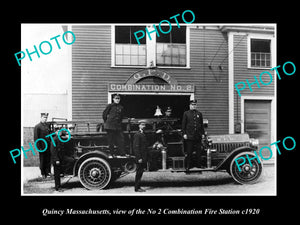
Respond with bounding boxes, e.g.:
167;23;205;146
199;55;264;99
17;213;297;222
72;25;136;123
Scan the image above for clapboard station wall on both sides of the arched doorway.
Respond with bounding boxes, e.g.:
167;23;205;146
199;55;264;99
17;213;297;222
72;25;228;134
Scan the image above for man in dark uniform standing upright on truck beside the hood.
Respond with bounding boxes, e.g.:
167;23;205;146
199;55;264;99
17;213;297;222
182;100;204;172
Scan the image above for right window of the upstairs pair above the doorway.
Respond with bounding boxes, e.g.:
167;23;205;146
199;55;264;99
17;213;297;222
156;26;187;67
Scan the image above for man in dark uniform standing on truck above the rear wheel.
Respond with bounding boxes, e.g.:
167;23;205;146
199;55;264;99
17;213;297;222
102;94;125;156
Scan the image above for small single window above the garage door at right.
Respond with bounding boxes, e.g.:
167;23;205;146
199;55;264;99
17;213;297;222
250;39;271;68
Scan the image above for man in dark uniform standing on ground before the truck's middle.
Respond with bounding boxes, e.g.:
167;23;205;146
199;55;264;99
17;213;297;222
133;120;148;192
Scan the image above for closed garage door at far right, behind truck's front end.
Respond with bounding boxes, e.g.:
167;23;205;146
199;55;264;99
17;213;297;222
244;100;271;158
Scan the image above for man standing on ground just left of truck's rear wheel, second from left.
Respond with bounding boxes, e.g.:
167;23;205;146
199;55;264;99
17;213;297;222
50;128;75;191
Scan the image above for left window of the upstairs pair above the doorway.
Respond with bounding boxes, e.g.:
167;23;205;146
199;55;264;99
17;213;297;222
115;26;146;66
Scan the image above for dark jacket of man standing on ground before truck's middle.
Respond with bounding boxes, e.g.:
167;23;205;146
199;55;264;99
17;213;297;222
133;131;148;162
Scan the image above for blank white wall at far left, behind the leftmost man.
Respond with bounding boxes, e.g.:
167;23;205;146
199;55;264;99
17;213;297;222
21;24;71;166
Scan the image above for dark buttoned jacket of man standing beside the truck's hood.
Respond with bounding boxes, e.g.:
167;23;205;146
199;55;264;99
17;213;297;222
182;110;204;140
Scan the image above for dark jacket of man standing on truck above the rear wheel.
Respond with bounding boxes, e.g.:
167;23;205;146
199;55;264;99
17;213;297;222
102;103;124;130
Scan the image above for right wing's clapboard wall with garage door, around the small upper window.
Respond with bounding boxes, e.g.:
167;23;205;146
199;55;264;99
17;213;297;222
233;32;277;163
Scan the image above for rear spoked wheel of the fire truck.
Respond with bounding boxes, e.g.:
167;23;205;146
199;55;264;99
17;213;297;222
78;157;112;190
